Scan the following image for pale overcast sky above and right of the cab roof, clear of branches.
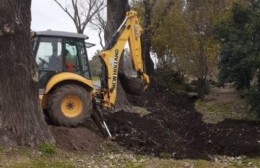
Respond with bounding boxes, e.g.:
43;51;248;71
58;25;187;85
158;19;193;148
31;0;101;58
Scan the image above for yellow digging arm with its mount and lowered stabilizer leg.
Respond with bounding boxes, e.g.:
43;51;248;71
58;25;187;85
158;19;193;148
92;10;150;137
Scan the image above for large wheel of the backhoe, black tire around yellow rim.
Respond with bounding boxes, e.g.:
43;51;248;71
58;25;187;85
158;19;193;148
48;84;92;126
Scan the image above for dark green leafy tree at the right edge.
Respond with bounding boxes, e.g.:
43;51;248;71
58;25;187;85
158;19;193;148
216;0;260;115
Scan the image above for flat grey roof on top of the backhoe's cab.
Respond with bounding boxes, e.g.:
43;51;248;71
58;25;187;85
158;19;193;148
36;30;88;39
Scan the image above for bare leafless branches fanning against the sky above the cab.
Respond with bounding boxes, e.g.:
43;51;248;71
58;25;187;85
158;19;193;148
54;0;106;34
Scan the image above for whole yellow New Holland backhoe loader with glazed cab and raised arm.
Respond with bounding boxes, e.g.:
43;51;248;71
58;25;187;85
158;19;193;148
32;10;149;136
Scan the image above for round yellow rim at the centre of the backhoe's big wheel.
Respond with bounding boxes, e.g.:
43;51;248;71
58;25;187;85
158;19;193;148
61;95;83;118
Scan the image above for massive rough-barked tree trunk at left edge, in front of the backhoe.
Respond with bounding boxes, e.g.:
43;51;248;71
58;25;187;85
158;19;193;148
0;0;54;146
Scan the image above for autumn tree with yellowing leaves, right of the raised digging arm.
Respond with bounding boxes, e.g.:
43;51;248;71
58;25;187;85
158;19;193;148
152;0;228;98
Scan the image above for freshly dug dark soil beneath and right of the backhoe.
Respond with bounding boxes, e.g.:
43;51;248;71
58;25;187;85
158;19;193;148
50;82;260;159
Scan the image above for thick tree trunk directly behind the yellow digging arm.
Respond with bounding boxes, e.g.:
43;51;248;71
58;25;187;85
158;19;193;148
105;0;130;111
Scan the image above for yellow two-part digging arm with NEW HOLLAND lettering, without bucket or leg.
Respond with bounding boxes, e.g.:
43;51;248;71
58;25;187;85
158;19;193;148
100;10;150;109
